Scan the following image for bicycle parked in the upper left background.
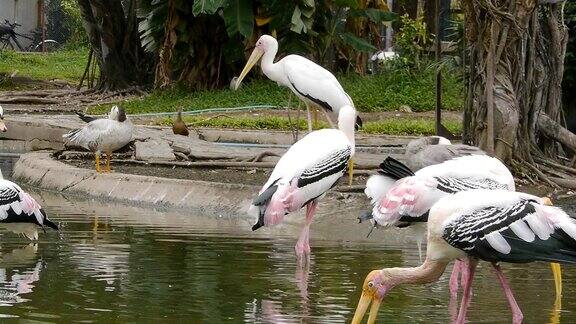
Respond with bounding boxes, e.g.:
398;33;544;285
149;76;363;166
0;19;60;52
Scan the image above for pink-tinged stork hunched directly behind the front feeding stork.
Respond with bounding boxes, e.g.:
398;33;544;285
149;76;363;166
359;155;562;298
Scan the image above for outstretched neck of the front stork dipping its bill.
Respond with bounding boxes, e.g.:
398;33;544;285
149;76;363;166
383;258;448;286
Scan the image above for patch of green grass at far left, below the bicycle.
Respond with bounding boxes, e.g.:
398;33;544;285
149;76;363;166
0;48;88;83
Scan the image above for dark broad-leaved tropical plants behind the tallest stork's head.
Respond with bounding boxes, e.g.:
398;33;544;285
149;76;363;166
139;0;394;89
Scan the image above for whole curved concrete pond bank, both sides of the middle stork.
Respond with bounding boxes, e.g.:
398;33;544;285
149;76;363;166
13;152;381;241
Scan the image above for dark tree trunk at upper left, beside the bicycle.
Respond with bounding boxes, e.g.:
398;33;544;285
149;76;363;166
78;0;150;91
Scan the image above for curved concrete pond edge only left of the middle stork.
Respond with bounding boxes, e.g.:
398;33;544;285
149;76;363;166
13;152;258;213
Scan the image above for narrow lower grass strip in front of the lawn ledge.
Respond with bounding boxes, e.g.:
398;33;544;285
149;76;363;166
155;116;462;135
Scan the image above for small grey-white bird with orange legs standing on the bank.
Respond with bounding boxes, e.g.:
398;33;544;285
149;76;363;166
62;106;134;173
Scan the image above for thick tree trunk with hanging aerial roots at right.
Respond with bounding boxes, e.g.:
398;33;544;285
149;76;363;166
462;0;568;162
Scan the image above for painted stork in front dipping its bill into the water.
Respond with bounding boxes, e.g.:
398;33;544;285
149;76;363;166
352;189;576;324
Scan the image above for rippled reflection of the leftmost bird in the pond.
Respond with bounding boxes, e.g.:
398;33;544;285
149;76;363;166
0;243;44;306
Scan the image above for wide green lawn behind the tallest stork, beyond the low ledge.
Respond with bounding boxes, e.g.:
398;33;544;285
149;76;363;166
90;64;464;114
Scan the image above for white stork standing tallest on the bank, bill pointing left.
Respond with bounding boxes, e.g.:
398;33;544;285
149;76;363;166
234;35;362;184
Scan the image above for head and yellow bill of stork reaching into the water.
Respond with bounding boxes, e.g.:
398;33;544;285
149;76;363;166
352;269;394;324
